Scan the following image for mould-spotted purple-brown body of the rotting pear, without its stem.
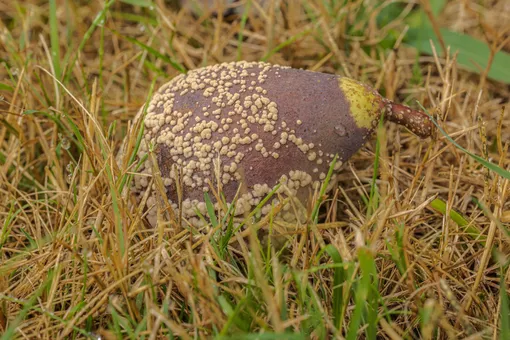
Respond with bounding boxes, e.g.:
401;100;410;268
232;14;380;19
125;62;432;223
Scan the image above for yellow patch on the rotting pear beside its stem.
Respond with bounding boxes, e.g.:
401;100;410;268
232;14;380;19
338;77;381;129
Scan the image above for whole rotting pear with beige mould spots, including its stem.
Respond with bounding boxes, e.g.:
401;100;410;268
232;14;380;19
122;62;432;226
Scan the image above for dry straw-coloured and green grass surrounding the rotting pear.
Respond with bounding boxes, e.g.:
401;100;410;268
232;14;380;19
0;0;510;340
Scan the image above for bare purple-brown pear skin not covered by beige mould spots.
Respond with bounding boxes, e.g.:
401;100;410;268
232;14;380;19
158;69;372;200
